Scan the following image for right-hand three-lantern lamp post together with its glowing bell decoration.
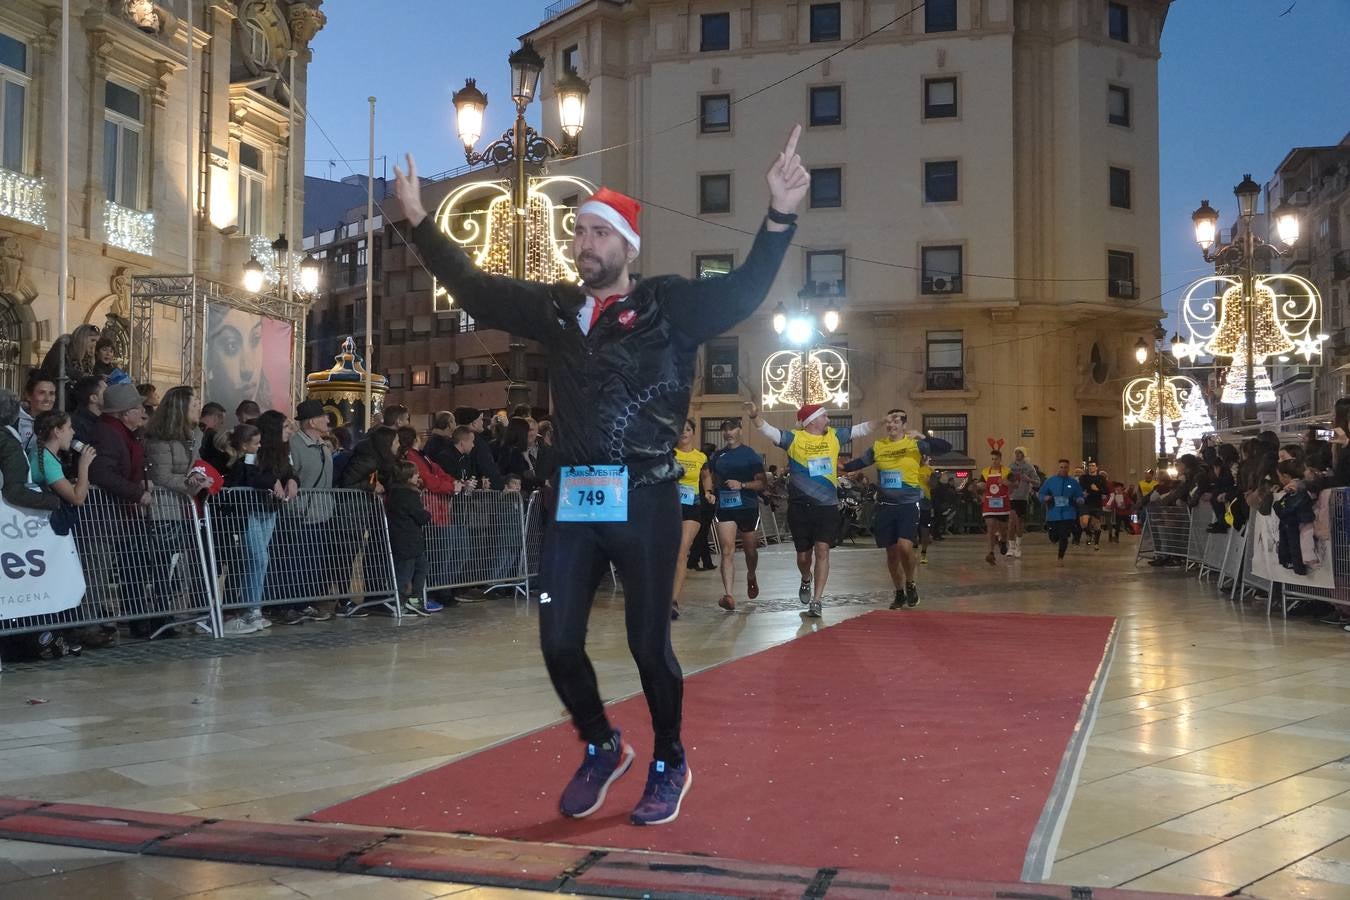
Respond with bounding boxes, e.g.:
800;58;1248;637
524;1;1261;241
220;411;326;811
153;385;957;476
1173;175;1306;425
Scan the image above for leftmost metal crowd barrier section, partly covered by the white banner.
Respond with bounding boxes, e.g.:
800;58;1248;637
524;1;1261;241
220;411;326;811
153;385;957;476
0;487;220;637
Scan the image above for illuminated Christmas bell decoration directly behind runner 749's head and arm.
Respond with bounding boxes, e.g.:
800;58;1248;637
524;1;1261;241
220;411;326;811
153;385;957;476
432;175;595;312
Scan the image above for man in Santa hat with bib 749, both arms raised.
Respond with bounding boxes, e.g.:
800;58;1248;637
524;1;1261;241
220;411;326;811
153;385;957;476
394;127;810;824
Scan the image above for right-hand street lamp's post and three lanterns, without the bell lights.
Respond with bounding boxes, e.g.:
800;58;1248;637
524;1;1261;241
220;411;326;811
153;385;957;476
1191;174;1299;425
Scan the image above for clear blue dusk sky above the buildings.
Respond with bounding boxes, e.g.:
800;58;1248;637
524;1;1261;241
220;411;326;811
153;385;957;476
305;0;1350;323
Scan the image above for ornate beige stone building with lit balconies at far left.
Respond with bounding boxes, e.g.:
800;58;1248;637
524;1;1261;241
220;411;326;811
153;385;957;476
0;0;325;389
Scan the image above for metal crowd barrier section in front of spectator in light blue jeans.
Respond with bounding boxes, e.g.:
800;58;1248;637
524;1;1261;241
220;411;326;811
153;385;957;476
199;487;402;618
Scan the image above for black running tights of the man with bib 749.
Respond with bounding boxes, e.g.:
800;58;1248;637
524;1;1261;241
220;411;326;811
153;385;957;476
539;483;684;765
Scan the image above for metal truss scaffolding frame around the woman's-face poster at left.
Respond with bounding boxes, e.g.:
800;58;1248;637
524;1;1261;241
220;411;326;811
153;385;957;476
128;274;309;398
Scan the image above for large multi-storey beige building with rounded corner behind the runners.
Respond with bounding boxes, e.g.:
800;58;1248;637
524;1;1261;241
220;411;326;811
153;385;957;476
527;0;1168;475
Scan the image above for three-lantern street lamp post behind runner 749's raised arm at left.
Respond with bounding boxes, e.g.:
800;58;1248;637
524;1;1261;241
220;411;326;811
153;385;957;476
452;40;590;406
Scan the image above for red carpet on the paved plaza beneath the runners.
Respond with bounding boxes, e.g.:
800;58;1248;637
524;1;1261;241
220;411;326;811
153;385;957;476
311;611;1114;880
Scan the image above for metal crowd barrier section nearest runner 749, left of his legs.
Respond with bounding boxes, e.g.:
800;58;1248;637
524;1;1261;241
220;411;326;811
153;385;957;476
423;491;529;594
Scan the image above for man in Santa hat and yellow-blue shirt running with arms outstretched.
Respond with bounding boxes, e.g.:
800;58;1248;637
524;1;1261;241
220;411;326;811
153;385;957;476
745;402;873;618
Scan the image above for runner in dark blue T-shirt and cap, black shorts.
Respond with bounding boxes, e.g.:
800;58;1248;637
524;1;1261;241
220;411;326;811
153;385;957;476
703;418;765;610
